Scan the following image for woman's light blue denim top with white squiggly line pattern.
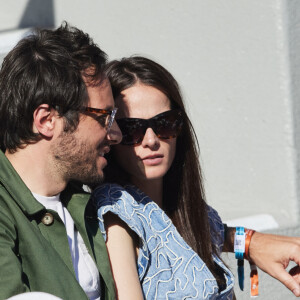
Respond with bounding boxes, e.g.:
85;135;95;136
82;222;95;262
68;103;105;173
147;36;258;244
92;184;234;300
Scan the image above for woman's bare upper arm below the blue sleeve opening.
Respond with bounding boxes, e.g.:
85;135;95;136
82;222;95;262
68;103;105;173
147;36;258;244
104;213;144;300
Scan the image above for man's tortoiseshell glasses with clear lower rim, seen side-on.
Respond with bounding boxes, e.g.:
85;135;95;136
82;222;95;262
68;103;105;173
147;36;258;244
83;106;118;132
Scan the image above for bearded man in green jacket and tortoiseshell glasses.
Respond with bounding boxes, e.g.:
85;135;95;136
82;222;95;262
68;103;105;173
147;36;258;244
0;24;121;299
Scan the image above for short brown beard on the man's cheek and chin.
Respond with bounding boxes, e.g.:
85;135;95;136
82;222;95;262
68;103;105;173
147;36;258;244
52;132;104;186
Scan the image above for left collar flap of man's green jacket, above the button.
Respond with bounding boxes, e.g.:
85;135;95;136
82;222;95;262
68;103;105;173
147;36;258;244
0;150;45;215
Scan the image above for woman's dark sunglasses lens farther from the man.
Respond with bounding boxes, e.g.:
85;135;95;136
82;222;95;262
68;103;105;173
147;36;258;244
153;110;183;139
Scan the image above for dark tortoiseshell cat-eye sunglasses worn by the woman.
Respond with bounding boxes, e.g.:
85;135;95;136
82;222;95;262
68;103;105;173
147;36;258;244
117;109;183;145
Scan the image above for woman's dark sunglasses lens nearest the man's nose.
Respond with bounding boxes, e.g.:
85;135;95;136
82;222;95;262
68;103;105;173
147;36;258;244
117;119;146;145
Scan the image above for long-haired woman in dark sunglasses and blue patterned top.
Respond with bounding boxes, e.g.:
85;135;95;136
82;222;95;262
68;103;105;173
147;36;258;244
93;57;233;299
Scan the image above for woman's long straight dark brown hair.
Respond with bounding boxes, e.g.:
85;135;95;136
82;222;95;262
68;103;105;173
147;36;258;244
105;56;224;277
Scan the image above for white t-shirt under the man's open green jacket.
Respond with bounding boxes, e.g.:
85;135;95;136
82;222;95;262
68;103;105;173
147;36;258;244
32;193;100;300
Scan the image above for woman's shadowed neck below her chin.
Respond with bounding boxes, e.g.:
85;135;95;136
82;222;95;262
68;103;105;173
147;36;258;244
131;178;163;207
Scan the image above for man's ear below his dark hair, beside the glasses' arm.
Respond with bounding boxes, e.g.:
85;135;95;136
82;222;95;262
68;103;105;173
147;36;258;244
33;104;58;138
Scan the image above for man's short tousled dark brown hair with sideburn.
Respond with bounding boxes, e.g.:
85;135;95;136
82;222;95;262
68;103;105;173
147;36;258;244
0;22;107;152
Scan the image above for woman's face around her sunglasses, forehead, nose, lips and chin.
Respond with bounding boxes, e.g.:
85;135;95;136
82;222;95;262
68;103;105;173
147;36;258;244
113;84;176;184
